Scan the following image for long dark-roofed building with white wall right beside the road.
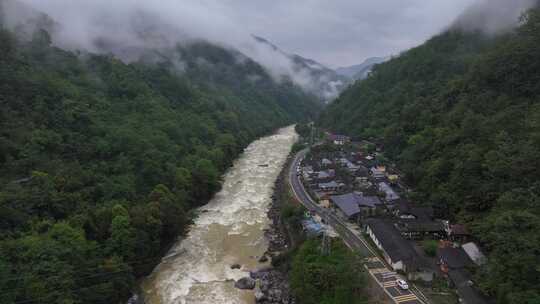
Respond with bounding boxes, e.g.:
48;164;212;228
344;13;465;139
366;218;435;282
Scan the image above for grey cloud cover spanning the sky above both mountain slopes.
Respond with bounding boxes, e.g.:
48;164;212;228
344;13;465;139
14;0;481;70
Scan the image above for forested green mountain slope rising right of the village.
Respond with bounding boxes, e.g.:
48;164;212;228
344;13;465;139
319;9;540;304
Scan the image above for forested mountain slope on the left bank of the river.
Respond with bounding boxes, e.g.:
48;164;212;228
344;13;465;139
0;21;320;303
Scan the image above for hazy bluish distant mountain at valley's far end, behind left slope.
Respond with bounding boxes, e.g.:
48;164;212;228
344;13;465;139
253;36;350;102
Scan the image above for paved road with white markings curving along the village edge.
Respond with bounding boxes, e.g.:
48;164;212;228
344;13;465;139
289;149;425;304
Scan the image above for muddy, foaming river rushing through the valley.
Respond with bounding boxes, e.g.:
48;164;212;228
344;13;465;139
142;127;297;304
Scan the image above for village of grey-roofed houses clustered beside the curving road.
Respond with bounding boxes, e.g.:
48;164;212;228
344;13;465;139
296;134;490;304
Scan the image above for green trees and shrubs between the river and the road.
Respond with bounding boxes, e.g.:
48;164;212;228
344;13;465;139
272;124;367;304
